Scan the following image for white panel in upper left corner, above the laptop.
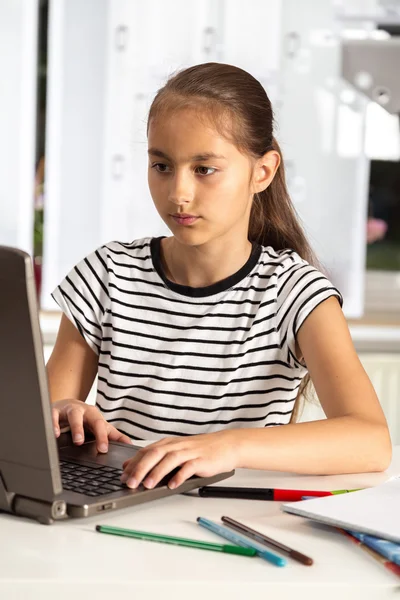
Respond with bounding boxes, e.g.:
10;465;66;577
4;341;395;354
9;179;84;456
0;0;38;254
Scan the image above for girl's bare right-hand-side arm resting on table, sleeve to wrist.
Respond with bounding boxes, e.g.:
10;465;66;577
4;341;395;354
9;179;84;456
236;298;391;474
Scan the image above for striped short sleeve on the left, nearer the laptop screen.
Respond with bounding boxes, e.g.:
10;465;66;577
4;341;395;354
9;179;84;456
52;247;109;354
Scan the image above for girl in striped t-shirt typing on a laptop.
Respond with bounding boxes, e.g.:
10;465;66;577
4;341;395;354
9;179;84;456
48;63;391;488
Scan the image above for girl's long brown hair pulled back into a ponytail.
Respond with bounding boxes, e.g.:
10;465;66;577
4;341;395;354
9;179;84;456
147;63;319;421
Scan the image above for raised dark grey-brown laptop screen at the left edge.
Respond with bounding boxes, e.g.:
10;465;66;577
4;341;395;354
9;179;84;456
0;246;62;501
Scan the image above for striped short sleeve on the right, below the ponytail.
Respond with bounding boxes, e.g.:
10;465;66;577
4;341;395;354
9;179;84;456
277;252;343;369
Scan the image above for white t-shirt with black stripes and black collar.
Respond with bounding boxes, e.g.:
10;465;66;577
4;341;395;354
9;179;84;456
53;238;342;439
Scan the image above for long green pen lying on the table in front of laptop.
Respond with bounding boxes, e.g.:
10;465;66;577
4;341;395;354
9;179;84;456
96;525;257;556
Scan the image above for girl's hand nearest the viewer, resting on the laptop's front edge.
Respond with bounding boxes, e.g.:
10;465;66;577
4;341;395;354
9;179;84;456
121;430;239;489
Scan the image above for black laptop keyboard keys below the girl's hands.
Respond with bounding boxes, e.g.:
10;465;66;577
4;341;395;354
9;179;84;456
60;460;126;496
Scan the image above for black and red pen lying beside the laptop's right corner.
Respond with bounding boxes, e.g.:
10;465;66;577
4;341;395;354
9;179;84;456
199;485;358;502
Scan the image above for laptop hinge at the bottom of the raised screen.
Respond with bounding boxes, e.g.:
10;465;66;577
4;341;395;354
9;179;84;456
0;473;68;525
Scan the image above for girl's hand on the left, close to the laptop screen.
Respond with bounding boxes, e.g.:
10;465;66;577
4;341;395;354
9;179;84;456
52;399;132;452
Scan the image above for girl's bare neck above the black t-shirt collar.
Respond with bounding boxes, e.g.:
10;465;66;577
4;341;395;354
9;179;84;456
161;237;252;288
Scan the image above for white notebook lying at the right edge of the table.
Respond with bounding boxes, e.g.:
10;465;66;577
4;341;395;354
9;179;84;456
281;477;400;543
